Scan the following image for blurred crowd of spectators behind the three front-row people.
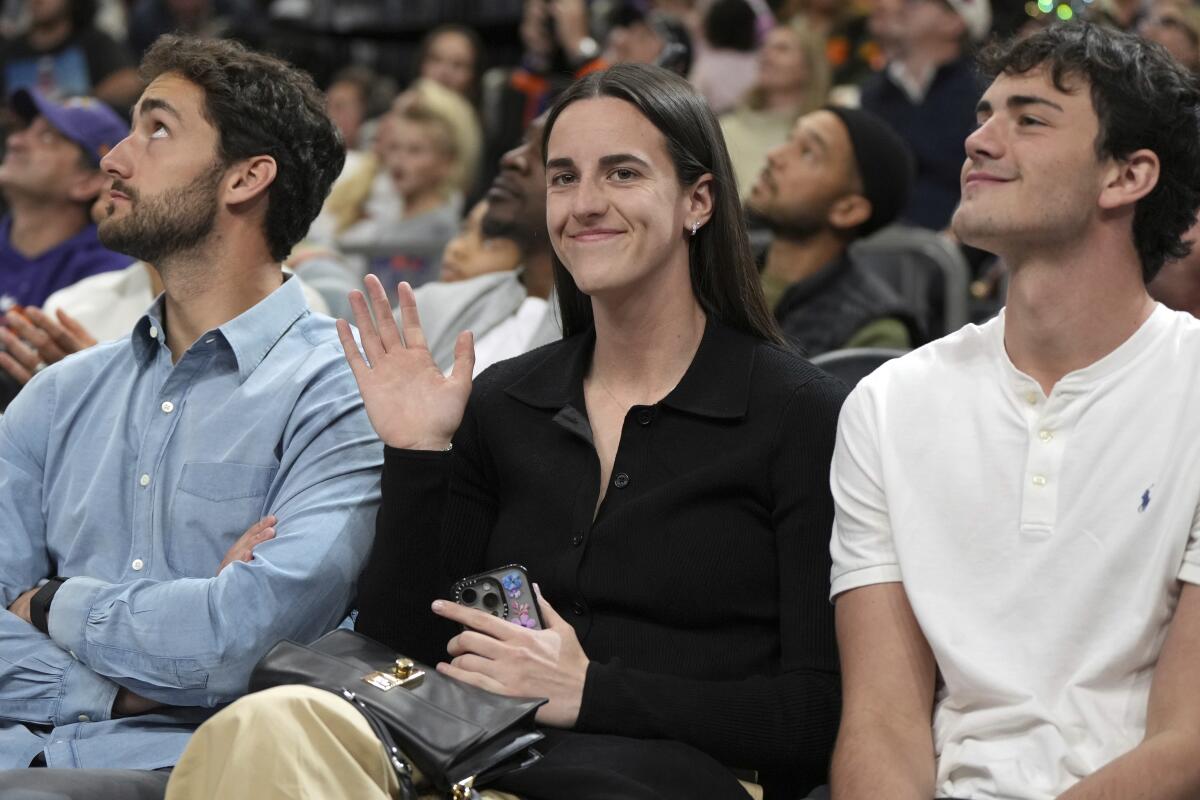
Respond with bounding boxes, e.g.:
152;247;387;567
0;0;1200;402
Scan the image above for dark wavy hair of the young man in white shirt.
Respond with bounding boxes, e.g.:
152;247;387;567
979;23;1200;283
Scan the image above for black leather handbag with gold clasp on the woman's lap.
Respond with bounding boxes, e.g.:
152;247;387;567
250;628;546;800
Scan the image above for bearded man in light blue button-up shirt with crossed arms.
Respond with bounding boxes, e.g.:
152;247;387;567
0;37;383;798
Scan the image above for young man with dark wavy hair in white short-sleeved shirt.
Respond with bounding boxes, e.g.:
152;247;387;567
832;25;1200;800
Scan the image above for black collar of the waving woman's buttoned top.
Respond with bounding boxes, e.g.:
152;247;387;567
505;318;758;419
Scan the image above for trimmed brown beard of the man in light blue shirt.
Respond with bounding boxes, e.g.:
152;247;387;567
98;161;224;266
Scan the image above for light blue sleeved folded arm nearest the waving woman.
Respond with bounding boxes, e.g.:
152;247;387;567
49;379;380;705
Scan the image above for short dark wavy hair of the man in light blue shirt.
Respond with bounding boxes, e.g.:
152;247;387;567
140;35;346;261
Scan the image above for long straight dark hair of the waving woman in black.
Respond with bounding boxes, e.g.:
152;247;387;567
541;64;784;343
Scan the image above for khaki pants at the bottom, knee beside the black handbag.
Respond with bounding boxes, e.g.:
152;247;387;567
167;686;762;800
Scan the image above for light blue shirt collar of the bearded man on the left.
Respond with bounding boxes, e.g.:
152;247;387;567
132;276;308;381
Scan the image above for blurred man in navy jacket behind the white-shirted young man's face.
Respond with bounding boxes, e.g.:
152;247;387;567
862;0;991;230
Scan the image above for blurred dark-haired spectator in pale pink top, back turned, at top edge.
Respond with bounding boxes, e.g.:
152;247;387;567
688;0;758;114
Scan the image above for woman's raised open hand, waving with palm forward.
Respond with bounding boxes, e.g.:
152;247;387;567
337;275;475;450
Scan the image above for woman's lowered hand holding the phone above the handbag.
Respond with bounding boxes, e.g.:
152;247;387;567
433;593;588;728
